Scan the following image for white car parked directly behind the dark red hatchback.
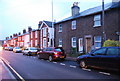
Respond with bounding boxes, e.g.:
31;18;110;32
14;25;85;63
22;47;38;55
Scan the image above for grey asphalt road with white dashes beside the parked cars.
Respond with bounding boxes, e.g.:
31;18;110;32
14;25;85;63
0;51;120;79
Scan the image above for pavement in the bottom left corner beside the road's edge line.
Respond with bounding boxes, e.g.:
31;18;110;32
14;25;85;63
0;59;15;81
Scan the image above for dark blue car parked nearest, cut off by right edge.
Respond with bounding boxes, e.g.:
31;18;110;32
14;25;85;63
77;47;120;71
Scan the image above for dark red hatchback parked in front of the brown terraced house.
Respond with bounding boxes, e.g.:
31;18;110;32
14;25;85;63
37;47;66;61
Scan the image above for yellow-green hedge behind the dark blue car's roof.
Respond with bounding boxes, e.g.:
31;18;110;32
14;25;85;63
103;40;120;47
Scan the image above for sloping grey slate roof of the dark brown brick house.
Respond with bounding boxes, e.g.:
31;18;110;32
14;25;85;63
55;2;120;24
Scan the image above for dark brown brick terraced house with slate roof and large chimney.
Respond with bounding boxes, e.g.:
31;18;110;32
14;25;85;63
55;2;120;54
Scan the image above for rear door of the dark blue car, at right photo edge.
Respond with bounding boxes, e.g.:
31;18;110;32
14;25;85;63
100;47;120;70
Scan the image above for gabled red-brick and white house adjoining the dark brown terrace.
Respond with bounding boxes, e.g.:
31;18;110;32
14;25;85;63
38;21;54;49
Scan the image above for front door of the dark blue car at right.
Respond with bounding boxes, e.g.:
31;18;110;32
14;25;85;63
87;48;106;67
